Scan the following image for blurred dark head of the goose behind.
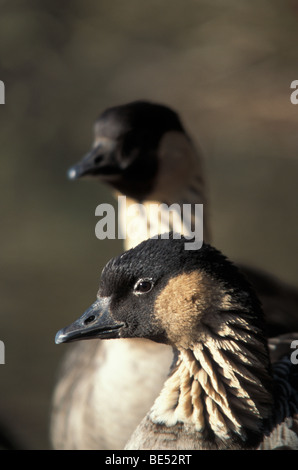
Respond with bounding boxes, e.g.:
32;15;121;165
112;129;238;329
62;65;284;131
68;101;205;201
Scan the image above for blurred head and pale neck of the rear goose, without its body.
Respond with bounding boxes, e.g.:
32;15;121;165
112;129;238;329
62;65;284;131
68;101;210;249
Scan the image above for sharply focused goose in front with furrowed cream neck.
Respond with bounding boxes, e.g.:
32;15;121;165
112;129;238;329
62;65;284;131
56;236;298;450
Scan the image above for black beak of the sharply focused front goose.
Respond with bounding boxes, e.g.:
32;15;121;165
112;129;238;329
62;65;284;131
55;297;125;344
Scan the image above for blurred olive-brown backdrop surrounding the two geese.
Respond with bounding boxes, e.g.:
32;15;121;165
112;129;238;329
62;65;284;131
0;0;298;449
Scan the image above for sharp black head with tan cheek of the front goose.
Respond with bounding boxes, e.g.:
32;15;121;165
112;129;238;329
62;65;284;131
56;234;263;349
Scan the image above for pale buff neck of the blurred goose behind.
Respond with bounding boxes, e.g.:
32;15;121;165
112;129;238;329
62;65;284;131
115;132;211;249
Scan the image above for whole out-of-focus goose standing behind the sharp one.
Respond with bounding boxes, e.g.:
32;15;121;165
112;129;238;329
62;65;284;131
51;101;298;449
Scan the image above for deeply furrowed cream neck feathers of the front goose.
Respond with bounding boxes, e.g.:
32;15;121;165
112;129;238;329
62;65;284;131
149;314;273;449
